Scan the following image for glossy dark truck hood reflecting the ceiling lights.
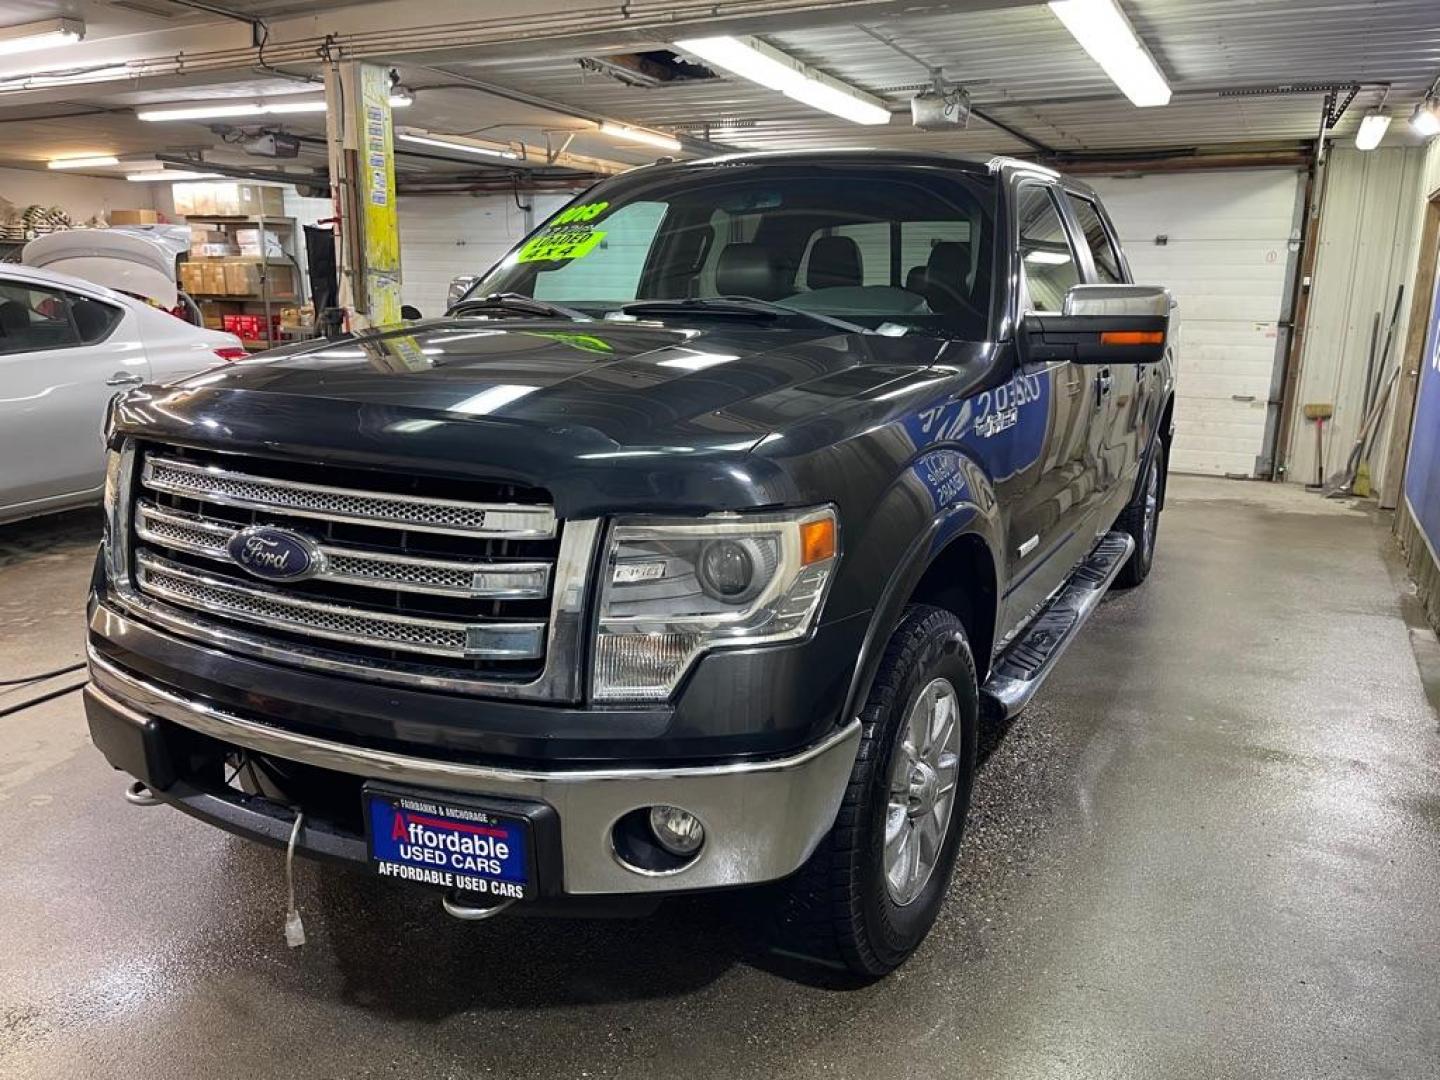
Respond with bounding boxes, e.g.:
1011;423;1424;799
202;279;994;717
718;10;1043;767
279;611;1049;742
115;318;943;517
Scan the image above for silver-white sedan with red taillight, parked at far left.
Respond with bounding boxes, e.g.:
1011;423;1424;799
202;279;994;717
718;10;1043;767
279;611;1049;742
0;265;245;523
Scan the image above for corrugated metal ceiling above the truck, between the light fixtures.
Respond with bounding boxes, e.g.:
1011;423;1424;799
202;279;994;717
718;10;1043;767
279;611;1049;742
474;0;1440;151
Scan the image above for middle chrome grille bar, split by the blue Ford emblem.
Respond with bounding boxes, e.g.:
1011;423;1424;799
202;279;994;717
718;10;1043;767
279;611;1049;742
135;500;550;600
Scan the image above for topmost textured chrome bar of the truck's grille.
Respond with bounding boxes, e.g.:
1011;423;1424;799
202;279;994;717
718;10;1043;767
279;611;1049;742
141;455;556;540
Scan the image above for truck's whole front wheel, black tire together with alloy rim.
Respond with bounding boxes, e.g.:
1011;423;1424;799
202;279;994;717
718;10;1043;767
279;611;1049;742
776;605;979;978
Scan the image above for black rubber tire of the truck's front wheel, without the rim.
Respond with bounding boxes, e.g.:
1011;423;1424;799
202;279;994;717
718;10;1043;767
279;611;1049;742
776;605;979;978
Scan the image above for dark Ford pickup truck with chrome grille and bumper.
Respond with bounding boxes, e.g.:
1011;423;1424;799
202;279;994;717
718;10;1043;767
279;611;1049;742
85;151;1174;976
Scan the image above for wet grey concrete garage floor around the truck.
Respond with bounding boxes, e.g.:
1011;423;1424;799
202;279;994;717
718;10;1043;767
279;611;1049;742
0;478;1440;1080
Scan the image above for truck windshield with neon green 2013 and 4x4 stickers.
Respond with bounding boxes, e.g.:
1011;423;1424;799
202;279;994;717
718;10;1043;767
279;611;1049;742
469;164;995;340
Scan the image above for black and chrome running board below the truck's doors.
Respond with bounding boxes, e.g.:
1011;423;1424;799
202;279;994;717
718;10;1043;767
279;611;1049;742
981;533;1135;719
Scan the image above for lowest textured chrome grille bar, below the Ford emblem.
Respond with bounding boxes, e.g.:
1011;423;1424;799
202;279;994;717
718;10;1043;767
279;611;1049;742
135;552;546;660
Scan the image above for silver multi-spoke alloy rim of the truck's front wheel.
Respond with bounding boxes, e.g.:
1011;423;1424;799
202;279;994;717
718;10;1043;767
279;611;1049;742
884;678;960;907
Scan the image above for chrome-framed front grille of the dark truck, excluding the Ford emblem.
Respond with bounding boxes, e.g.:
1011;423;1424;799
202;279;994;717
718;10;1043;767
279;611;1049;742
112;444;599;700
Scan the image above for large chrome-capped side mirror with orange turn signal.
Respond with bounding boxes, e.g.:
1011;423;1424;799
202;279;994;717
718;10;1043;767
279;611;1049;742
1018;285;1175;364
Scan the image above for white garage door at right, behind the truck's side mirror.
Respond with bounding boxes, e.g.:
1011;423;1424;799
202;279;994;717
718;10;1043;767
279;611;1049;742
1090;168;1300;477
